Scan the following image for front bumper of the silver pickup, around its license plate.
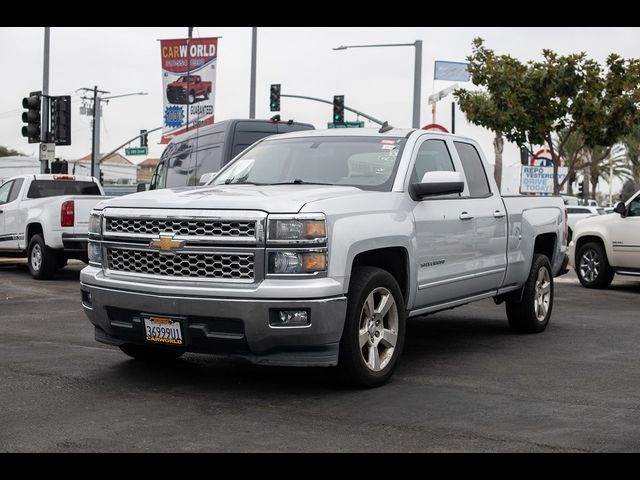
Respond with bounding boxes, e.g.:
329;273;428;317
80;282;347;366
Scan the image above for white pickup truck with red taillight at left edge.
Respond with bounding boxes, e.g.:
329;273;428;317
0;174;108;280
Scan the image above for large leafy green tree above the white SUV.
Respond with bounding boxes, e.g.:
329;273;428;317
454;38;640;194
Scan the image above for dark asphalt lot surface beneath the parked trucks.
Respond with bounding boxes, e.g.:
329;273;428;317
0;262;640;452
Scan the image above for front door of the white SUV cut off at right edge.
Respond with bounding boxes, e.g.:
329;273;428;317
610;193;640;270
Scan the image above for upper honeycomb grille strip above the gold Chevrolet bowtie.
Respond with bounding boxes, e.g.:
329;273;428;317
105;217;256;238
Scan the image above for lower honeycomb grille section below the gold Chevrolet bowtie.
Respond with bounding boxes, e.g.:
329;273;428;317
107;247;254;281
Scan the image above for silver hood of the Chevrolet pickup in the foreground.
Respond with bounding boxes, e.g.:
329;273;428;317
97;185;371;213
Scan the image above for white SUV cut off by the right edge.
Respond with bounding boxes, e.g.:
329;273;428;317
569;191;640;288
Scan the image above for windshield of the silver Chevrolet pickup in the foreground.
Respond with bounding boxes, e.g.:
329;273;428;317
211;137;406;191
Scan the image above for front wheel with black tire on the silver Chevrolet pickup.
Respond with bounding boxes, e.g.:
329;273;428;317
338;267;406;388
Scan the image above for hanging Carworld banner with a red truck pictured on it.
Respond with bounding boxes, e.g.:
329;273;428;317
160;37;218;143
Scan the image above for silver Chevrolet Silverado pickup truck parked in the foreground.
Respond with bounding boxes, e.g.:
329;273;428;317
80;129;568;387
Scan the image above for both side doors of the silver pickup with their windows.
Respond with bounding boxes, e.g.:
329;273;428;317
410;136;507;307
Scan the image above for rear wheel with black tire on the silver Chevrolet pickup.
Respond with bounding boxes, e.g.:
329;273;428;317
505;253;553;333
